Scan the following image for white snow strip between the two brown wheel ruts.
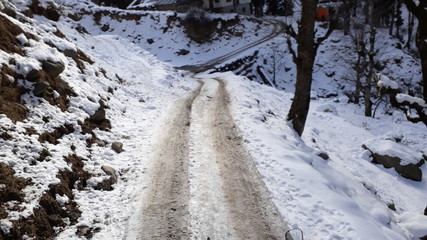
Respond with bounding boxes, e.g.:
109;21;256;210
189;80;239;240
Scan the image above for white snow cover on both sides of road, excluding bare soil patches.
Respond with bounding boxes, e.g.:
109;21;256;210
0;1;427;240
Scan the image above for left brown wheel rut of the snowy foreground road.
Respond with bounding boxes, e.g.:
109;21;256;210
141;82;202;240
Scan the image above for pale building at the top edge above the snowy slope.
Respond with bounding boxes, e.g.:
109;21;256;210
203;0;252;15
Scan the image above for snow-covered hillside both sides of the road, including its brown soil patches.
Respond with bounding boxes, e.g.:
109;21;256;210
0;0;427;240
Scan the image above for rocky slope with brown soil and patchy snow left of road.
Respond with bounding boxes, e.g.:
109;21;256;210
0;0;191;239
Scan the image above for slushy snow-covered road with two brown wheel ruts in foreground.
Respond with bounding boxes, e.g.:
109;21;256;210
141;79;286;239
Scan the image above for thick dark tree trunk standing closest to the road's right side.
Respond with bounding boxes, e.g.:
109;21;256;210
288;0;318;136
